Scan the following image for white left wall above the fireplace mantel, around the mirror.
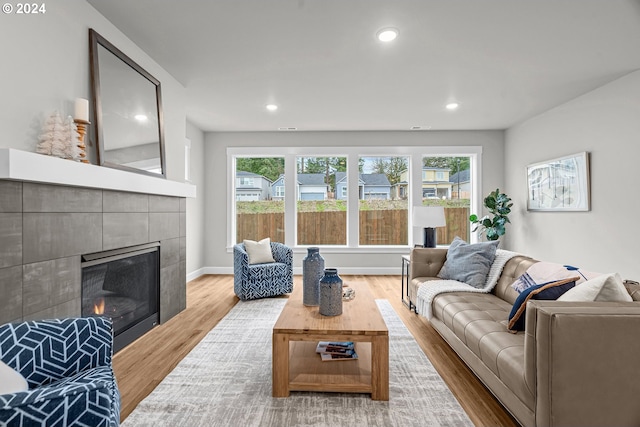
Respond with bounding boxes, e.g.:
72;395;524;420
0;0;204;278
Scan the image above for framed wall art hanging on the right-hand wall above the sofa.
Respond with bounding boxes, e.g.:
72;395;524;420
527;151;591;211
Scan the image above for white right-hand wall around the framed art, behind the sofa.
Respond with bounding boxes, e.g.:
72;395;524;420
505;71;640;280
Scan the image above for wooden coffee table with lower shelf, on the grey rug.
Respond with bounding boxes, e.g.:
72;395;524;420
272;282;389;400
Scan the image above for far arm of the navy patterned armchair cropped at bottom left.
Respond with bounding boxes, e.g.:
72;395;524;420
0;317;113;388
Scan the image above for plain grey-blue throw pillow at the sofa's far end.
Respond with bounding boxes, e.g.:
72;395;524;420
438;237;500;289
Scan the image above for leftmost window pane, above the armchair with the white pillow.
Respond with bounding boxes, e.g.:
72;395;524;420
234;157;285;243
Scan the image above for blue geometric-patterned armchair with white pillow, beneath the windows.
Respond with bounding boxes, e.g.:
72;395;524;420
233;242;293;301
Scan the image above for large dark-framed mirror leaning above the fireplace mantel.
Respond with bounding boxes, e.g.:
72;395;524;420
89;29;166;178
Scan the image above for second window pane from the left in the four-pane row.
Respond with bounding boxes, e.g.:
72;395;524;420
296;156;347;245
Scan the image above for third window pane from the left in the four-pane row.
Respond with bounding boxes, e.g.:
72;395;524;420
352;157;409;246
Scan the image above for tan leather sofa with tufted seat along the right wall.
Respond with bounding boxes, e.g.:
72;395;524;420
408;248;640;427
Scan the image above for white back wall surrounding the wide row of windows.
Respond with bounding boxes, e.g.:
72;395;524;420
204;131;504;274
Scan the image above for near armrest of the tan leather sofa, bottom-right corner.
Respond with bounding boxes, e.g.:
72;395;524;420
525;301;640;426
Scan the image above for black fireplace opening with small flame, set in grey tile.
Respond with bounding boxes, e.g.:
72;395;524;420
81;243;160;352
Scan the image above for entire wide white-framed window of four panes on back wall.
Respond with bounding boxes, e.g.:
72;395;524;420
227;146;482;249
